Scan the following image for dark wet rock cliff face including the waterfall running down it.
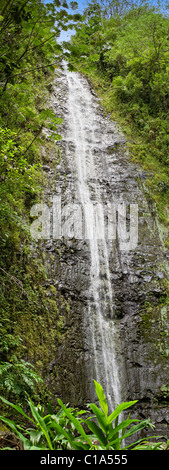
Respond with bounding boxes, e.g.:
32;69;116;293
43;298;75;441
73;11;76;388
39;65;169;434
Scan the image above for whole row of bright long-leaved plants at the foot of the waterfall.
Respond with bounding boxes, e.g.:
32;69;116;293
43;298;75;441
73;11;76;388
0;381;169;450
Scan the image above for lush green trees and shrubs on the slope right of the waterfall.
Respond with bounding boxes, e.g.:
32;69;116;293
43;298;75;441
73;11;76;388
68;0;169;242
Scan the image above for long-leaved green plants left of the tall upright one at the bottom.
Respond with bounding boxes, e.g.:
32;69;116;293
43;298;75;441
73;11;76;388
0;397;92;450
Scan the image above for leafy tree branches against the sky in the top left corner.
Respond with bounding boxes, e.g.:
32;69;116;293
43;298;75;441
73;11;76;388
0;0;80;91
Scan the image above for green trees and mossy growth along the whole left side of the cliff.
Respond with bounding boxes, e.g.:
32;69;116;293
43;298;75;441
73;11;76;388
0;0;80;402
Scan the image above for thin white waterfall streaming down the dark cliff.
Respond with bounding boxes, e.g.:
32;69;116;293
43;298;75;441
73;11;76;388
65;70;121;409
